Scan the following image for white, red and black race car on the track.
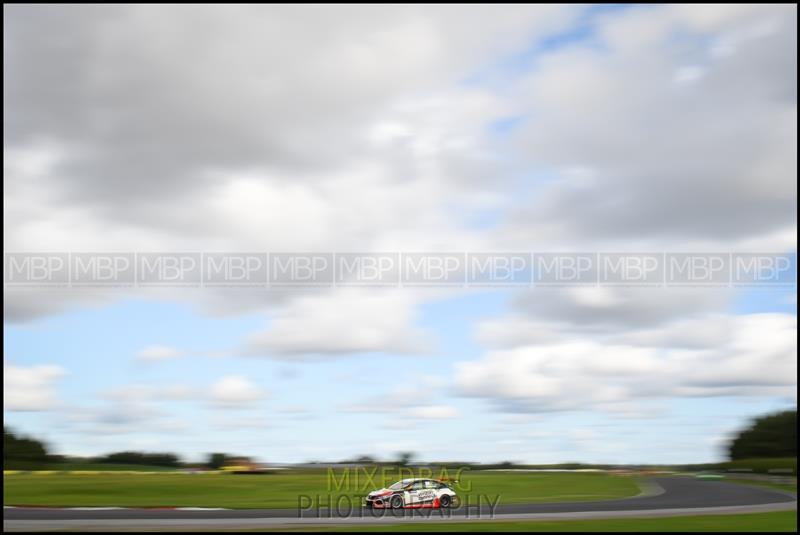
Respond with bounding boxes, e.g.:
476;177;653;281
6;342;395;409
366;479;458;509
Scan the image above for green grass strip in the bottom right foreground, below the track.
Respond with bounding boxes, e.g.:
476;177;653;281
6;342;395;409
265;511;797;533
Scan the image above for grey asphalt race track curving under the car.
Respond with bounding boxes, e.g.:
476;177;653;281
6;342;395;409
3;477;797;531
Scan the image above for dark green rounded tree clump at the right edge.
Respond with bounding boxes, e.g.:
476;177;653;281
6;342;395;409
728;409;797;461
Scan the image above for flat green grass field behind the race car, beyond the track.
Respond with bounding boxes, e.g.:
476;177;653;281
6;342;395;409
3;471;640;508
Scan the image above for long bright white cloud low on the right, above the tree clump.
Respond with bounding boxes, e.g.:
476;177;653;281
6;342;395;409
455;314;797;412
